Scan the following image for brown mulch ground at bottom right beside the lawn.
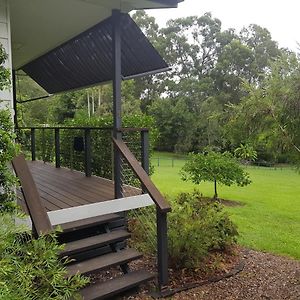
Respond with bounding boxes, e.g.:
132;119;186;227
125;249;300;300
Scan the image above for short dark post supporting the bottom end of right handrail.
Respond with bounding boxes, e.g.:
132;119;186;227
156;207;169;291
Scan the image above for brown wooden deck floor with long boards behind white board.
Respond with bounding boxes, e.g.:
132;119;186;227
21;161;114;211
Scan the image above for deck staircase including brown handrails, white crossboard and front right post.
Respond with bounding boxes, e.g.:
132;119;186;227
12;144;170;300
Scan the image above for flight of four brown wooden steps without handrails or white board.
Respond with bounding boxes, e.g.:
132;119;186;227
60;214;154;300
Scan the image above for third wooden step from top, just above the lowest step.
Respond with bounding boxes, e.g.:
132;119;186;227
67;249;142;276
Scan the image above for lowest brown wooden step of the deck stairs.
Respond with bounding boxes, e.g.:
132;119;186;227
80;270;154;300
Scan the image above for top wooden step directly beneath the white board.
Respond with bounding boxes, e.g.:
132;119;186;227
59;214;121;233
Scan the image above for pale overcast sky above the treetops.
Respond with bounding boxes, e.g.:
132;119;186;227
147;0;300;52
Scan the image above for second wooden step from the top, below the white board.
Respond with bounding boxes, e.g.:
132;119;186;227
60;230;130;256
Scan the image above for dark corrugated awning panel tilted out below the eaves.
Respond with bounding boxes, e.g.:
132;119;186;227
21;14;168;94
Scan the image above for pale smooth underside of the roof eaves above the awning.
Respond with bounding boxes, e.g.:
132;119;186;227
8;0;181;70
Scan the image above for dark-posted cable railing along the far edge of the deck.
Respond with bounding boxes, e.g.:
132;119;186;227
18;126;149;179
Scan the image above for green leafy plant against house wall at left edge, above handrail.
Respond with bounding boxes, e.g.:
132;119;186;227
0;110;19;210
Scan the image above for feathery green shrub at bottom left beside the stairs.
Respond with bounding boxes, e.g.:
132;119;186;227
0;213;88;300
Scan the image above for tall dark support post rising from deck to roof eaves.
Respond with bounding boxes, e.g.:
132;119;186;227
112;10;122;198
